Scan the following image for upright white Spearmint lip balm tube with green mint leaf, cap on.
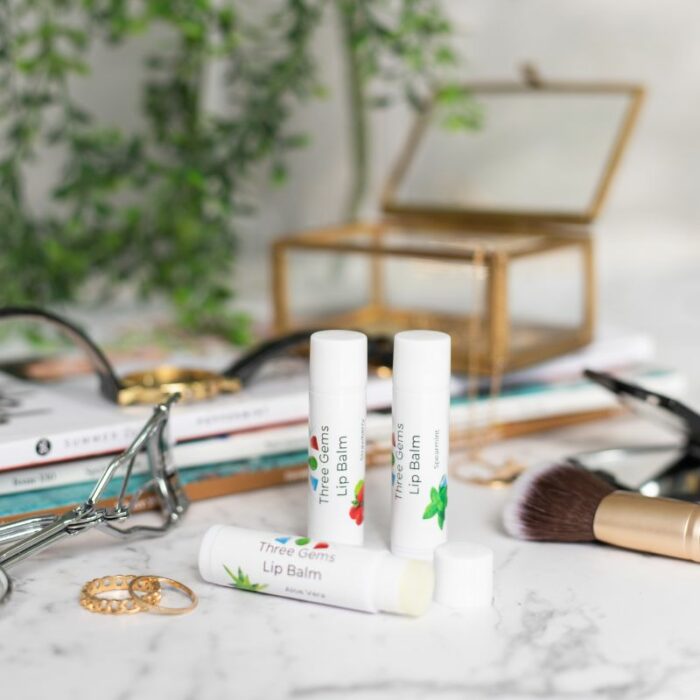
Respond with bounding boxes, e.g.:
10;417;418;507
391;331;451;559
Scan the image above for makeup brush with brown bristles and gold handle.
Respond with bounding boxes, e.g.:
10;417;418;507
503;463;700;562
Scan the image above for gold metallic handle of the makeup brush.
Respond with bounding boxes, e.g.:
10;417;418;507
593;491;700;562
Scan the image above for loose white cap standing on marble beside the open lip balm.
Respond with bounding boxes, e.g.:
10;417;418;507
434;542;493;609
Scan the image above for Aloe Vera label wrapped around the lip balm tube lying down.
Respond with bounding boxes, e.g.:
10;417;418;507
208;527;381;610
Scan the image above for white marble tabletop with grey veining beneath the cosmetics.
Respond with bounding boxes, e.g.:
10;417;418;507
0;412;700;700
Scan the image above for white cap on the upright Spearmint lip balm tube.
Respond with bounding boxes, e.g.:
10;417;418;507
393;331;451;391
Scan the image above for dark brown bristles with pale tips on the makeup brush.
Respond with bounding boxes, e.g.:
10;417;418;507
503;463;615;542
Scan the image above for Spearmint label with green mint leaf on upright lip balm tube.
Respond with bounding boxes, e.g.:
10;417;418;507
391;399;449;550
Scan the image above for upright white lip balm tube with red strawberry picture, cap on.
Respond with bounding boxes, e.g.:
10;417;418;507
308;331;367;545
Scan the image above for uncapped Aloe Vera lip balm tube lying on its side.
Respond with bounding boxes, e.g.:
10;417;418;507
199;525;433;616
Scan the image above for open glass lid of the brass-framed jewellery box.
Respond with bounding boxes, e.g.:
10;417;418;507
383;71;643;223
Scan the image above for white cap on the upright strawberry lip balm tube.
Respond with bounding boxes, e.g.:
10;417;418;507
309;331;367;393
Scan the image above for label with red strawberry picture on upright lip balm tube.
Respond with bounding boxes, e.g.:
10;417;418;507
309;392;365;544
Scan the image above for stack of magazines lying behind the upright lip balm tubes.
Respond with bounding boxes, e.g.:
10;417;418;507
0;335;683;520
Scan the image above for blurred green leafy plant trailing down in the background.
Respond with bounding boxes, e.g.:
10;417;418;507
0;0;470;343
